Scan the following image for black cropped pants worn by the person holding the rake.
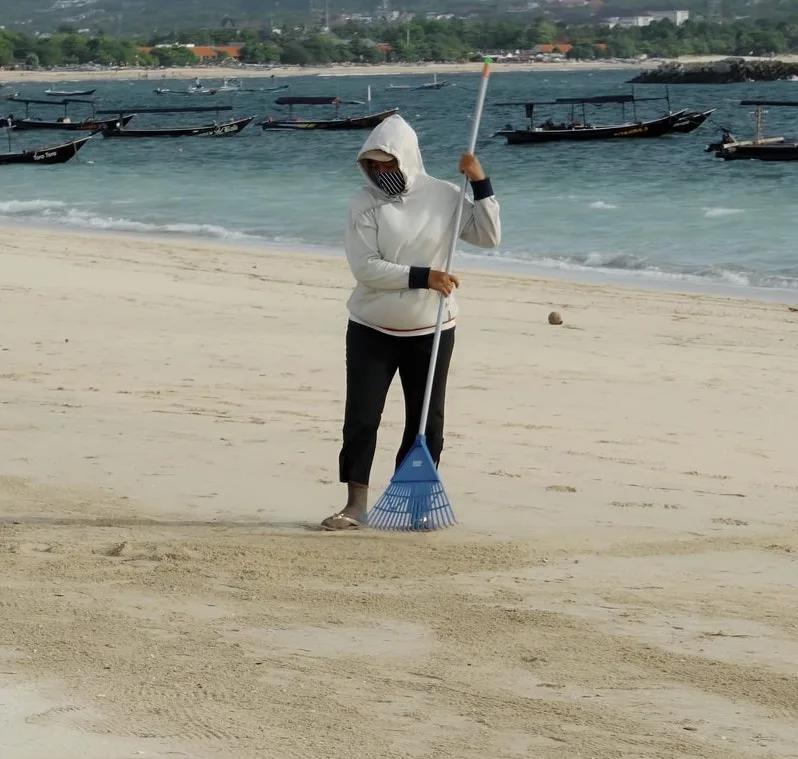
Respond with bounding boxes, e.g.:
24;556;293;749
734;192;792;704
338;321;454;485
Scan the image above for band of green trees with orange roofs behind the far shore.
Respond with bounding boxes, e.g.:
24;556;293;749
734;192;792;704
0;17;798;67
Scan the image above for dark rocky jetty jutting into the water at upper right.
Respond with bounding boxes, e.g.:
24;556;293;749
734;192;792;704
629;58;798;84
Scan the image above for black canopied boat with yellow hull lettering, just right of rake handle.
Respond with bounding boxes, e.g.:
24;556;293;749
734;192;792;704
494;94;688;145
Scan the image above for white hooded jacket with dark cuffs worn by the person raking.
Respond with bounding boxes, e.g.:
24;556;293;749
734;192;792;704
345;115;501;335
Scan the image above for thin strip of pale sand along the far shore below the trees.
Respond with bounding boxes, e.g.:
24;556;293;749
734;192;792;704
0;55;798;85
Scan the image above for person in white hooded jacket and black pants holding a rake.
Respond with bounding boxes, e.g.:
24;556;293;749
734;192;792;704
321;115;501;530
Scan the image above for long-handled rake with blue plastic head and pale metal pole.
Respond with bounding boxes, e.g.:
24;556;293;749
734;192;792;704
366;58;491;531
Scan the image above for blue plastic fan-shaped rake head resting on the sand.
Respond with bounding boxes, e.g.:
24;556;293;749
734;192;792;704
366;435;457;532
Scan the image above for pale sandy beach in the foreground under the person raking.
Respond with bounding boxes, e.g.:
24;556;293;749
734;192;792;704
0;228;798;759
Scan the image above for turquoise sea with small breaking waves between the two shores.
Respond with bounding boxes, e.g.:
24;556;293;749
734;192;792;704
0;69;798;300
